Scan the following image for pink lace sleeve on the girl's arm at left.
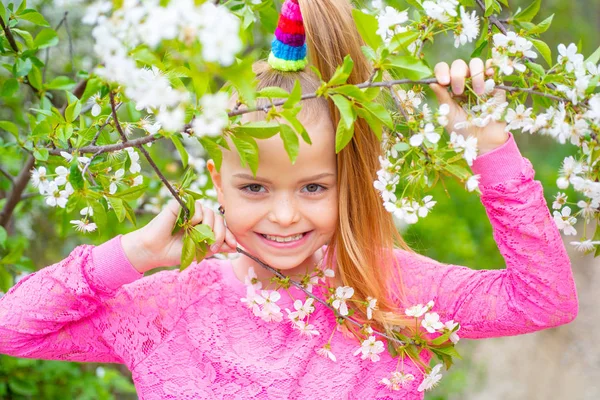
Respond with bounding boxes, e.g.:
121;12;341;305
0;235;214;368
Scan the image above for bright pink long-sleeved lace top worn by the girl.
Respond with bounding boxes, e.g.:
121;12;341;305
0;135;578;400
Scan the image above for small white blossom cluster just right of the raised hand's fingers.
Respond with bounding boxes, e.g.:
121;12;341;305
492;32;537;75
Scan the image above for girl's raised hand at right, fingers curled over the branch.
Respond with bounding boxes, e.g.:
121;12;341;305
430;58;509;155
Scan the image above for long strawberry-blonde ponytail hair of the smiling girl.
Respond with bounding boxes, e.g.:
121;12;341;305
239;0;414;340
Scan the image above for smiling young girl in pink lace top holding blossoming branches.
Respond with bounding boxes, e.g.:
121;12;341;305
0;0;578;400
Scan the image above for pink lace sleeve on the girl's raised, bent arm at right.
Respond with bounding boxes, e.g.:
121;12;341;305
396;134;579;338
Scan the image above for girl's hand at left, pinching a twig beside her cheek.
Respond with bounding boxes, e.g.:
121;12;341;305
121;200;237;273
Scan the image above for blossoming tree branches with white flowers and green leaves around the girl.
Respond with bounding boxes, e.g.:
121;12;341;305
0;0;600;396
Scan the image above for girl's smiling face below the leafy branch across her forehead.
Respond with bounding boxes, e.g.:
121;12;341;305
208;115;338;273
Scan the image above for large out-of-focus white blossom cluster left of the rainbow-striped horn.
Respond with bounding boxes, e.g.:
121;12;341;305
83;0;242;131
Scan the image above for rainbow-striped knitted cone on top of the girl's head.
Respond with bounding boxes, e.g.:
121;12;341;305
269;0;307;71
